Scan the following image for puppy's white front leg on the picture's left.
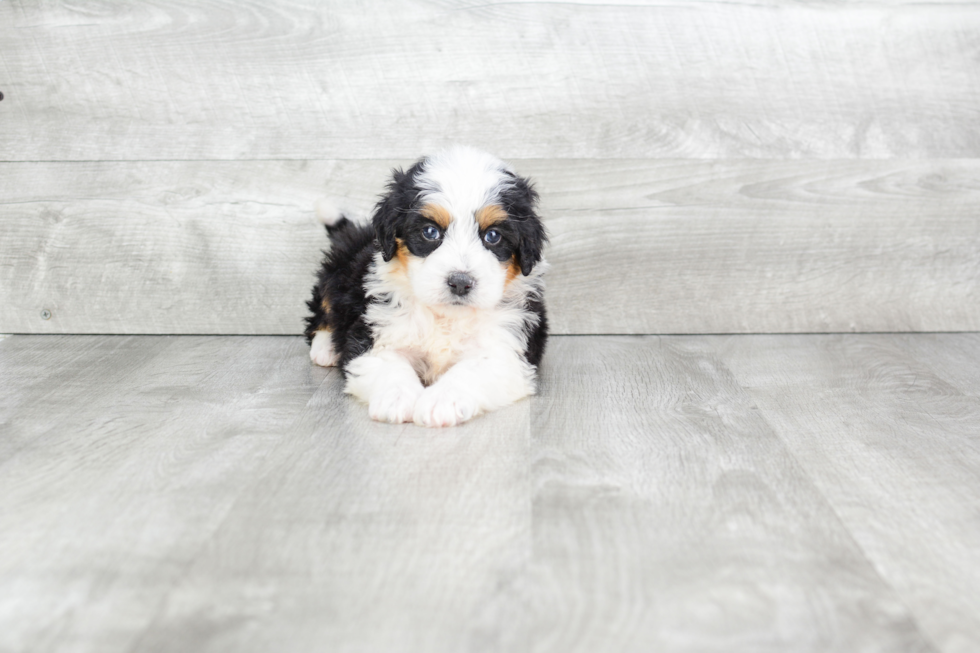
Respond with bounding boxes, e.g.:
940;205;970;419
344;351;423;424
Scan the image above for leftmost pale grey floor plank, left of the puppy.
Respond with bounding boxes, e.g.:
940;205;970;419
0;336;315;651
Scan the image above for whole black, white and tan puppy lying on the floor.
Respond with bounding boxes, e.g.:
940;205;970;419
306;147;547;426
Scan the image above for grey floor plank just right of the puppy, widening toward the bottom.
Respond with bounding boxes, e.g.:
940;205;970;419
521;337;932;651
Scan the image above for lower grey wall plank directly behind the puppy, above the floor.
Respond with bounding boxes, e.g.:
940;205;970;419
0;160;980;334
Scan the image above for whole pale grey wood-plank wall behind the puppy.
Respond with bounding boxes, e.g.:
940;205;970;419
0;0;980;334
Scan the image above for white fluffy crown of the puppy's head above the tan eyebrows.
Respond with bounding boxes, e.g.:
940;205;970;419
415;146;514;219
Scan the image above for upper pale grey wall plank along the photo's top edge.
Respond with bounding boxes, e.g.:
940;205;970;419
0;0;980;161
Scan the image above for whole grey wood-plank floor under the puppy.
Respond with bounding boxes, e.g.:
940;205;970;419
0;334;980;652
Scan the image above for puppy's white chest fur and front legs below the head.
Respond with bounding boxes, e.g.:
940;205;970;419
346;254;546;426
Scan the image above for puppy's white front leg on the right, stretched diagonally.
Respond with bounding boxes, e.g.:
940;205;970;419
413;350;534;426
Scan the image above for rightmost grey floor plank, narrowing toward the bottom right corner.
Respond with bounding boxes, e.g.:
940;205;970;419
717;334;980;653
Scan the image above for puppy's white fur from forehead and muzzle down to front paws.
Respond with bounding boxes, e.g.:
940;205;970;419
346;148;547;426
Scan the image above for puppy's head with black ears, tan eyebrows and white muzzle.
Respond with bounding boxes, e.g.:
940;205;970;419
372;147;546;308
